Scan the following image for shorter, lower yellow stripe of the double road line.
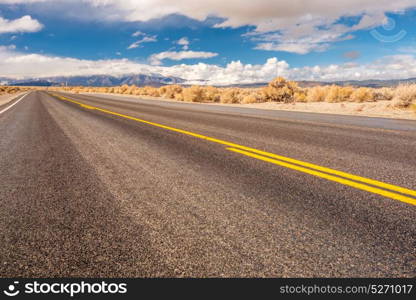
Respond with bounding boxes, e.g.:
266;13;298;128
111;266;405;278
227;148;416;205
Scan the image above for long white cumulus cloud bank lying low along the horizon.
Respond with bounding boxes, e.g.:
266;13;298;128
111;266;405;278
0;46;416;85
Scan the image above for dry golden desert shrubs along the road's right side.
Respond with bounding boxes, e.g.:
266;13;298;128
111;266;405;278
50;77;416;109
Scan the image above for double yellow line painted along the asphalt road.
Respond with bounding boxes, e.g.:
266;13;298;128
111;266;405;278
49;94;416;205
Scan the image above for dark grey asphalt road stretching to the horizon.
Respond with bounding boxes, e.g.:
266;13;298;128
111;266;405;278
0;92;416;277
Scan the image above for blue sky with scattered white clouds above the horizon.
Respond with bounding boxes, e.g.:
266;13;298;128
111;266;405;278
0;0;416;84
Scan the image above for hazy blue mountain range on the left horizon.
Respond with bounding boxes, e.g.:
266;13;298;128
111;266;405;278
0;74;185;86
